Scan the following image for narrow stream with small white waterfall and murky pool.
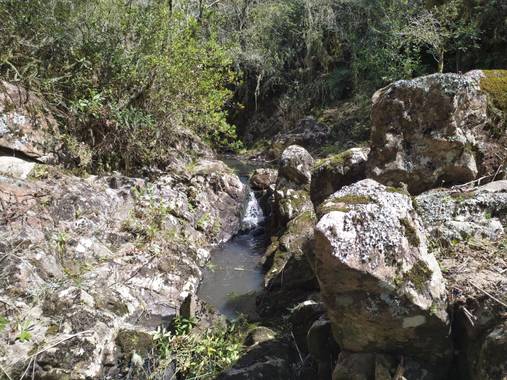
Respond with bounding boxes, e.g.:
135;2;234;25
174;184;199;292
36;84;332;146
197;160;265;319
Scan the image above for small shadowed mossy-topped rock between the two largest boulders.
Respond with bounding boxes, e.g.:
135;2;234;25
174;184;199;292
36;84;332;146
310;148;370;205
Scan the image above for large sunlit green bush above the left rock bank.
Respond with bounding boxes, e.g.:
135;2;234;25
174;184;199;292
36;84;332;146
0;0;242;171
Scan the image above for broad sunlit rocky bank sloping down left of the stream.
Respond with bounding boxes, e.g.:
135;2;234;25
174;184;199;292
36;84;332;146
0;161;243;379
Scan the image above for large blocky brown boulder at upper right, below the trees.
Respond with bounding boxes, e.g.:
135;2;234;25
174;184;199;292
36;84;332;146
368;71;506;194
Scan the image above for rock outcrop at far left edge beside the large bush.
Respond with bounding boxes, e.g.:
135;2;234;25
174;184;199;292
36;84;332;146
0;81;59;162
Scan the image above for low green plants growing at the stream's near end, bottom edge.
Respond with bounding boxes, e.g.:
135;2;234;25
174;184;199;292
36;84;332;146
154;318;245;379
